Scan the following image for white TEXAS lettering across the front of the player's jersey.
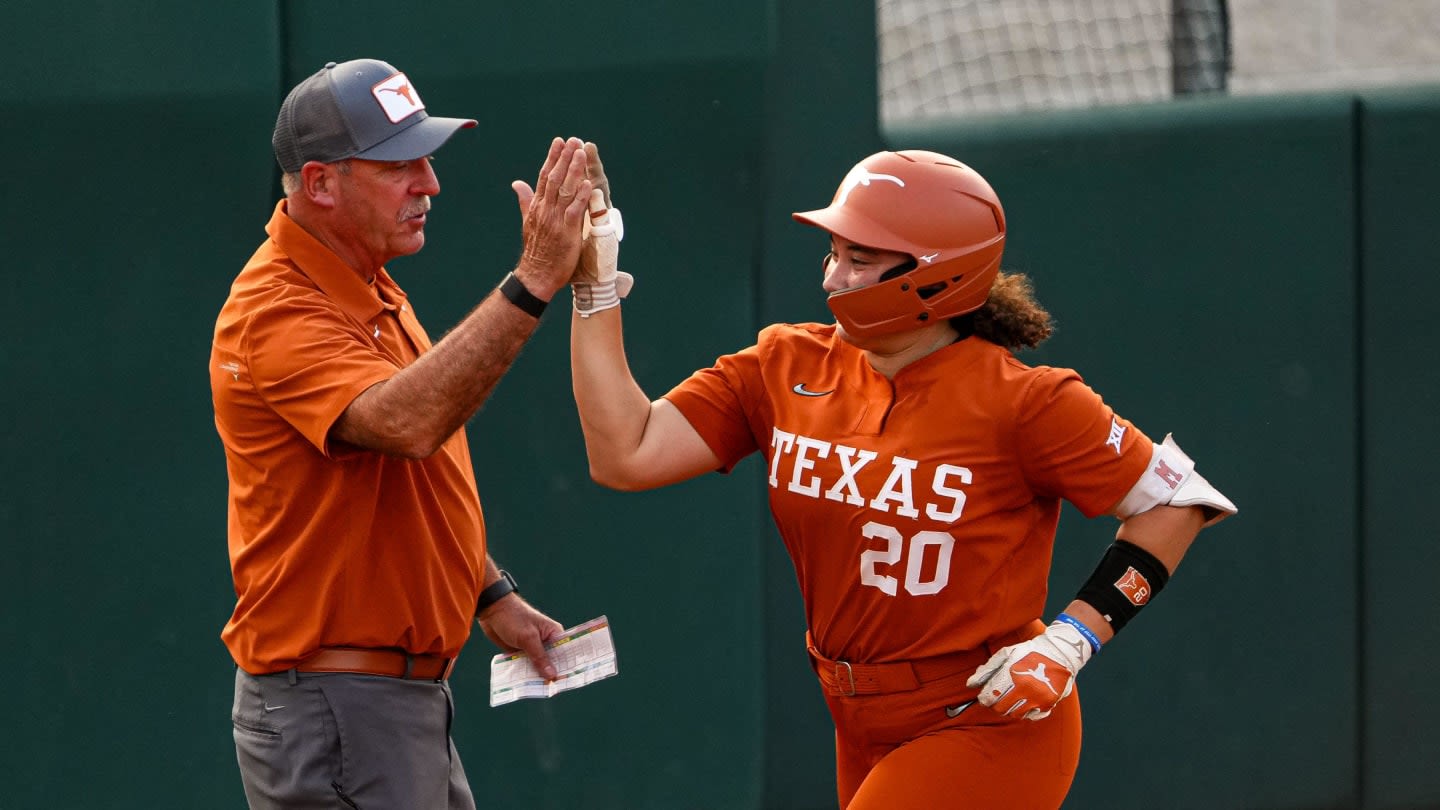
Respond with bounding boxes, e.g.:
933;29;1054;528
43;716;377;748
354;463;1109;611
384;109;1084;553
769;427;973;523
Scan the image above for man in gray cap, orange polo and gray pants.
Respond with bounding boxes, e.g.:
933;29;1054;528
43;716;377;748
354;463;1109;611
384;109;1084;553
210;59;592;810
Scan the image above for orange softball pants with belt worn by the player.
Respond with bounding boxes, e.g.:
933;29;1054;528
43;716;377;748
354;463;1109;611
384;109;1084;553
812;623;1081;810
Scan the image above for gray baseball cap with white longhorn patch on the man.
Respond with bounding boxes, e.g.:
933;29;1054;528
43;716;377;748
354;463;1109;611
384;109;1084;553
271;59;475;173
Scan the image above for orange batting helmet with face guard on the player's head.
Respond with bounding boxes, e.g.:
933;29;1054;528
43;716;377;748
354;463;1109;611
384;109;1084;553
793;150;1005;337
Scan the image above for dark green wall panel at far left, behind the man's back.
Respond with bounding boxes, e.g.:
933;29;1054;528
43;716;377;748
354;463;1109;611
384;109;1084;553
0;0;279;810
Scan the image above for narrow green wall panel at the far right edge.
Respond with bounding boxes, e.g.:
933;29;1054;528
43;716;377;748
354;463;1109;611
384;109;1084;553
1359;86;1440;810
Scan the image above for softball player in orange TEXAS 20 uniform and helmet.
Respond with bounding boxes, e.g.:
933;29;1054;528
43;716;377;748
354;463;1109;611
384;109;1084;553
555;151;1236;810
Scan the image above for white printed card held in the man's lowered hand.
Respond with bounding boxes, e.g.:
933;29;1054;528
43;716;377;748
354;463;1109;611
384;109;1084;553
490;615;619;706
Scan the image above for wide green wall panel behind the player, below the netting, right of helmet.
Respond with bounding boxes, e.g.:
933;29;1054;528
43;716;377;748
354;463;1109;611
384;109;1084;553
887;97;1358;810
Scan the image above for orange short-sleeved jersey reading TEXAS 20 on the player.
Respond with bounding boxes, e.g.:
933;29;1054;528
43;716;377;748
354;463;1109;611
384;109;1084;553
665;324;1152;663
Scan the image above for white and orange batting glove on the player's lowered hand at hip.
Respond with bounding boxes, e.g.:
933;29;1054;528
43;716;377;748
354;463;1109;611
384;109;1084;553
965;620;1094;721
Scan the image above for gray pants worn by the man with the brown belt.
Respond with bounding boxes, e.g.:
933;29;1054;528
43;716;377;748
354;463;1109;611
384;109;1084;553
230;669;475;810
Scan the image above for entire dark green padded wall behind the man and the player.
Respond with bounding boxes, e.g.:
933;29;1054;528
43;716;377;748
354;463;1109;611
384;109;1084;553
0;0;1440;810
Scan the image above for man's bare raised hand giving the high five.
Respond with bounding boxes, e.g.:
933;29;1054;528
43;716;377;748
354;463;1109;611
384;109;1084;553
510;138;593;300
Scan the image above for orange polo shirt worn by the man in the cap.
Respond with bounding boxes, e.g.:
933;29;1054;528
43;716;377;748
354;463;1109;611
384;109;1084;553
210;200;485;675
